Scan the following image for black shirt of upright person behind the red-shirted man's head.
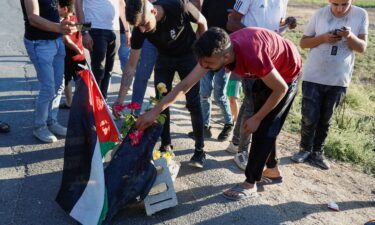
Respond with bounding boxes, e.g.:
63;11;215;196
202;0;235;30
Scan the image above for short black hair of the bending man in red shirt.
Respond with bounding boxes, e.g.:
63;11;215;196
193;27;232;58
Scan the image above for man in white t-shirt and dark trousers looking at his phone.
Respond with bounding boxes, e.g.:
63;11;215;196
292;0;369;169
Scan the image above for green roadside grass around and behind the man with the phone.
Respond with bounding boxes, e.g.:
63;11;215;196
283;15;375;174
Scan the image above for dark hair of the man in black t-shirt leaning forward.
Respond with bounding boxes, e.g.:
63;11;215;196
126;0;148;26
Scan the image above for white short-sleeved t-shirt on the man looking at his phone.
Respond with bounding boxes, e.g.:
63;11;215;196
303;5;369;87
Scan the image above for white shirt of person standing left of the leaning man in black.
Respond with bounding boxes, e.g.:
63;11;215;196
83;0;120;30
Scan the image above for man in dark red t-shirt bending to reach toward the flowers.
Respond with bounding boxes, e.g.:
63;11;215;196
137;27;302;200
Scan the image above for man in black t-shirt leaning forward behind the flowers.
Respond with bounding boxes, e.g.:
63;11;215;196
113;0;207;168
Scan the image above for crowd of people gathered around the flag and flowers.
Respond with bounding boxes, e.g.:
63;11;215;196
18;0;369;200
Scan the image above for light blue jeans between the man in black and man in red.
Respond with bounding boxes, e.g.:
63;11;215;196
200;68;233;127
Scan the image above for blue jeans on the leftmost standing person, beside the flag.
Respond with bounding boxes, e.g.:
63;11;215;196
24;38;65;128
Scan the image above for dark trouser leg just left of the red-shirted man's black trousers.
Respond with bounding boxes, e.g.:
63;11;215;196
232;79;255;152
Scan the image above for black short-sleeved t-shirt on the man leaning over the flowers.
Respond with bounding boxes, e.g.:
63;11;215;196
131;0;200;56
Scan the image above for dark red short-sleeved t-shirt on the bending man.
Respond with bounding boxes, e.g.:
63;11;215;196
230;27;302;83
